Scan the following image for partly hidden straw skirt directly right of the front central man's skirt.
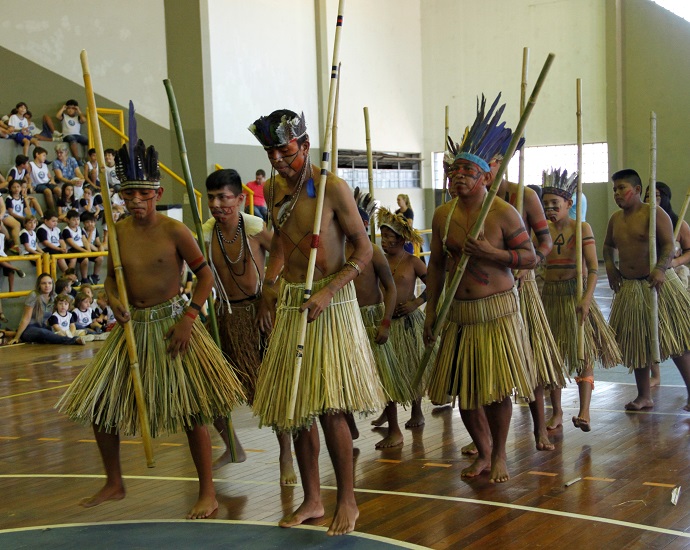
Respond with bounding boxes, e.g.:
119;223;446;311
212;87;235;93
359;304;415;405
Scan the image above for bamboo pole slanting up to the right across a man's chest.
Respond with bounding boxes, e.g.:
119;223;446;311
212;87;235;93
412;53;556;388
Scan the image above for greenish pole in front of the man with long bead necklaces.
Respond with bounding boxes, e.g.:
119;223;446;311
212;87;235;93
163;78;237;462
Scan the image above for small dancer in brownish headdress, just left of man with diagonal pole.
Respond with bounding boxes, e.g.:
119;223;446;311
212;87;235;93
372;208;426;428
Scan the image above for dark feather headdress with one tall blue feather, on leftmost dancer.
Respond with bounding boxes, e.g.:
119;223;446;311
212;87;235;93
115;101;161;189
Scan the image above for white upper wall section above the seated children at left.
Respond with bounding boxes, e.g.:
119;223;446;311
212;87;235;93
0;0;169;128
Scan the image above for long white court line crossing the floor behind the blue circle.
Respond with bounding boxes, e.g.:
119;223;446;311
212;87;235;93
0;474;690;539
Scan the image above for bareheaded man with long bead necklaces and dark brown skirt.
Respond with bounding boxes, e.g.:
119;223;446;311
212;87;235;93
204;169;297;485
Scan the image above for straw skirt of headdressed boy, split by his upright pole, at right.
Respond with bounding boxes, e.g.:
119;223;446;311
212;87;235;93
542;279;623;375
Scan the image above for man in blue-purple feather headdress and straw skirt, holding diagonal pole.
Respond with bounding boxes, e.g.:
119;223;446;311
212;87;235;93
424;96;536;483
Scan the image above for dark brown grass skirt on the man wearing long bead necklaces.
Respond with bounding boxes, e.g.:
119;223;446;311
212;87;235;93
216;301;266;405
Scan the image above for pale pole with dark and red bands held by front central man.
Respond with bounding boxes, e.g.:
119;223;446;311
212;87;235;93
288;0;345;420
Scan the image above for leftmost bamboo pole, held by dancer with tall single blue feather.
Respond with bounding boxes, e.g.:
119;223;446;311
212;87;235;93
80;50;156;468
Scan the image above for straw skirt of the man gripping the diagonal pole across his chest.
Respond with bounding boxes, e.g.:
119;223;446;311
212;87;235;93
429;288;536;409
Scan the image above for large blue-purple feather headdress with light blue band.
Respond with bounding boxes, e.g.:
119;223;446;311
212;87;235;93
444;93;525;172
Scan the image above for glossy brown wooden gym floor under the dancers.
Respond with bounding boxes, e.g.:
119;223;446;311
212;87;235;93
0;343;690;548
